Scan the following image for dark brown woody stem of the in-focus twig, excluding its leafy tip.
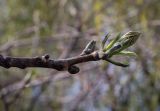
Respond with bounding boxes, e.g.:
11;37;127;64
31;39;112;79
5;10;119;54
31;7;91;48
0;51;105;73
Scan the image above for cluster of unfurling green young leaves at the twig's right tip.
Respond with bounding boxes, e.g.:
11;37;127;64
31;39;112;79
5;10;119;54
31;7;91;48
102;31;141;67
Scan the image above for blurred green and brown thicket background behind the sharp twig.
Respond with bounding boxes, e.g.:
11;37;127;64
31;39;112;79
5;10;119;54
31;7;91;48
0;0;160;111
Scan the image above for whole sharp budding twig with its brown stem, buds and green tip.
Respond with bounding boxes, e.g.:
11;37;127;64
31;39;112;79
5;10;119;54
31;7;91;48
0;31;140;74
